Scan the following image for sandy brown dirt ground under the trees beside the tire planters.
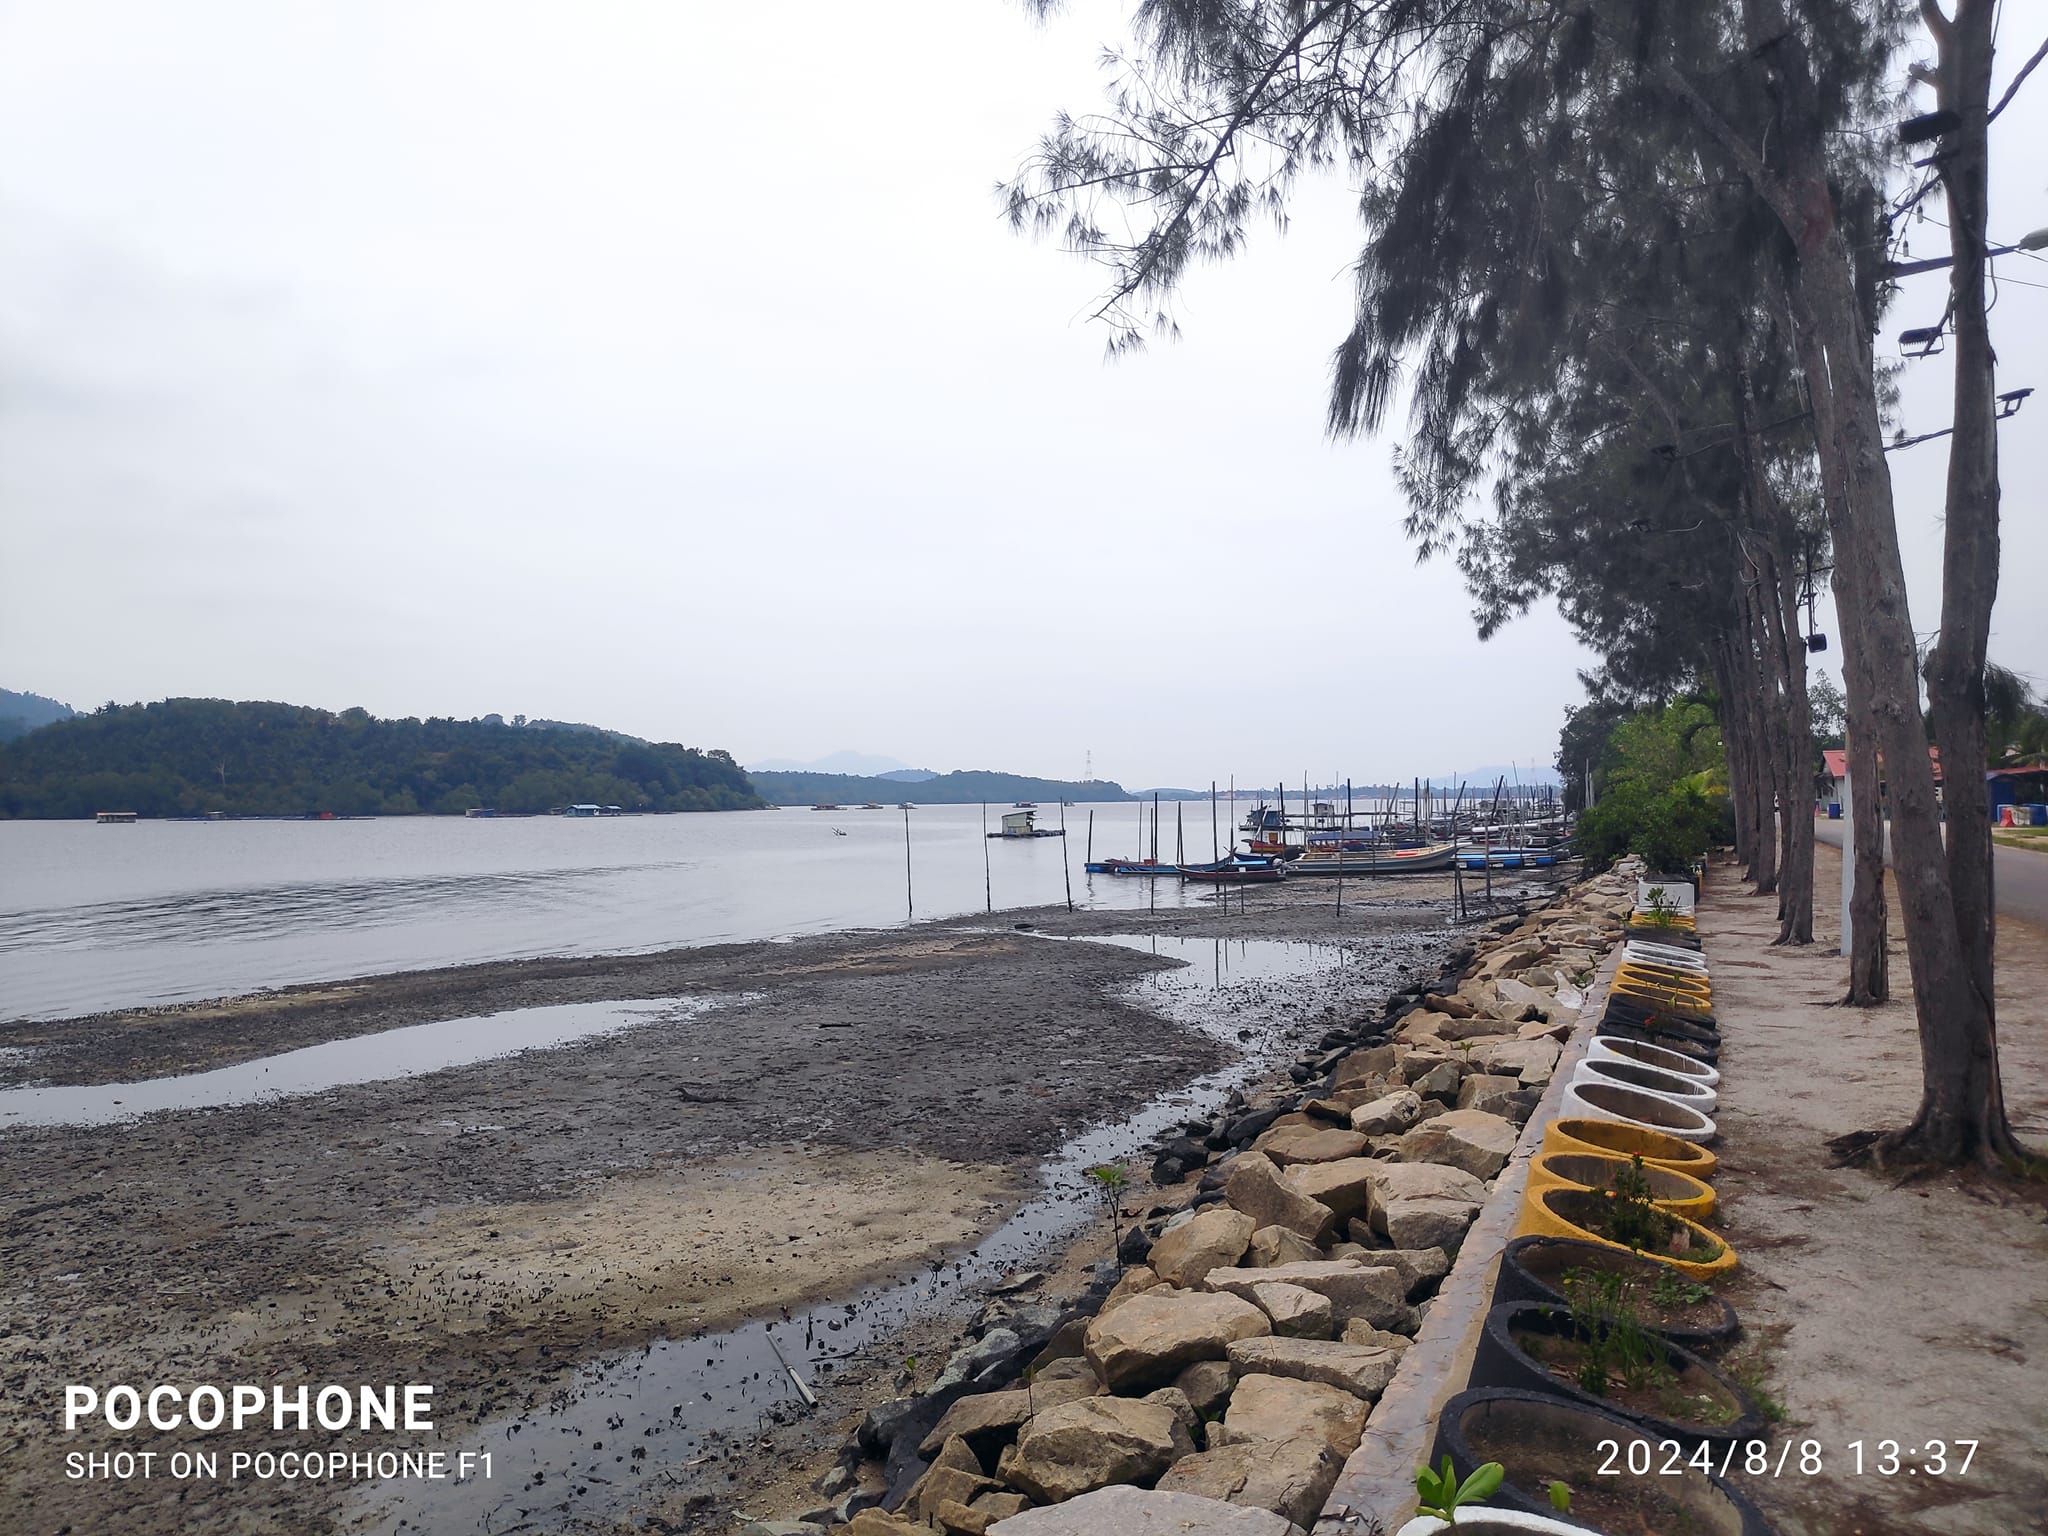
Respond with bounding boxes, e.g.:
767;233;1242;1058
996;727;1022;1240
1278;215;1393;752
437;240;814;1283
1700;846;2048;1536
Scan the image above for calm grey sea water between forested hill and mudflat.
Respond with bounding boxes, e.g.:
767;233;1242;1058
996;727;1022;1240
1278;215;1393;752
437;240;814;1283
0;803;1243;1018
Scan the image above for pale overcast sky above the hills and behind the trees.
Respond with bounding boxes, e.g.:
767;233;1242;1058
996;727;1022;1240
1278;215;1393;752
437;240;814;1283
0;0;2048;784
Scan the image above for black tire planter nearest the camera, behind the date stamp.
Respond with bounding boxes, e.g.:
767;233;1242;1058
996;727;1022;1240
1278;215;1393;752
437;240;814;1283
1430;1389;1772;1536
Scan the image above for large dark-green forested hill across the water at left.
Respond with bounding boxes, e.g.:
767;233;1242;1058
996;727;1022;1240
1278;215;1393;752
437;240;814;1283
0;698;760;817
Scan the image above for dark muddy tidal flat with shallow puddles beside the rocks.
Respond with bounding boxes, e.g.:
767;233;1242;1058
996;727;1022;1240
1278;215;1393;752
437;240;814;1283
0;883;1454;1534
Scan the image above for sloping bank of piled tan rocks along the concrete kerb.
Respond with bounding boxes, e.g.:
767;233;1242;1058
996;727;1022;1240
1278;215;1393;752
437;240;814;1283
750;872;1634;1536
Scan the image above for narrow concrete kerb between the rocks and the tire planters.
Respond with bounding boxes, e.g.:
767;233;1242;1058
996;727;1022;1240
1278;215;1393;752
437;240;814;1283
1315;921;1622;1536
